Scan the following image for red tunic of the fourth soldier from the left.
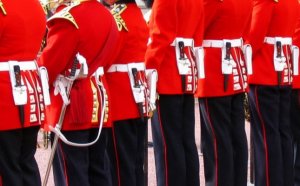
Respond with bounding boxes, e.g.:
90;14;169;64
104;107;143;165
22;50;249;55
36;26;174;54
145;0;203;94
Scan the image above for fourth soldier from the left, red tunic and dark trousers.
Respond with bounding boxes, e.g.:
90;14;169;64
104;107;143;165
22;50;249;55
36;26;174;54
146;0;203;186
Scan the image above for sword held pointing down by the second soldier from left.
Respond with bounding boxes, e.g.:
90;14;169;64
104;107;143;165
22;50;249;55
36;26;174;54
43;57;79;186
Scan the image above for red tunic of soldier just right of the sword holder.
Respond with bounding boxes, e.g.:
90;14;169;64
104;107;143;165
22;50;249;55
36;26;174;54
106;3;148;121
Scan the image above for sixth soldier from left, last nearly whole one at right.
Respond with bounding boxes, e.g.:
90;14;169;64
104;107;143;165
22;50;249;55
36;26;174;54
246;0;299;186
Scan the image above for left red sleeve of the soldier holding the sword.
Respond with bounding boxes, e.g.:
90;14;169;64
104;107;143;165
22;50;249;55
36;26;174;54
38;19;79;84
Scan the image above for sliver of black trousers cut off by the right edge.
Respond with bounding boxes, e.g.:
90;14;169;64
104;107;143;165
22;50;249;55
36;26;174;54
290;89;300;186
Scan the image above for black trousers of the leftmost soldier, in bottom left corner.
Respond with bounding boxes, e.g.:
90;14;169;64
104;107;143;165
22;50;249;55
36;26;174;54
0;127;41;186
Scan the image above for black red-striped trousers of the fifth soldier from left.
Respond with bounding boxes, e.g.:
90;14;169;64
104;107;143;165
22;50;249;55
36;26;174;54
199;94;248;186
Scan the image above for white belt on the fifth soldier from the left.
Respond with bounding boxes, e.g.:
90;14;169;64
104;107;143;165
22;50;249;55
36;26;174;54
202;38;243;48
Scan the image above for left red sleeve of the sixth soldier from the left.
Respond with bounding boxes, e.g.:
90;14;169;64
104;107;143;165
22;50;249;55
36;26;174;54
245;0;274;54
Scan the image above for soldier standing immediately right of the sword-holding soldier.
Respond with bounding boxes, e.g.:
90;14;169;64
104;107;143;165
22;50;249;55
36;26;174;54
106;0;149;186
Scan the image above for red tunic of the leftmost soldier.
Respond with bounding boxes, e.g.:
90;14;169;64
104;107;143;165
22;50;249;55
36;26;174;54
0;0;46;130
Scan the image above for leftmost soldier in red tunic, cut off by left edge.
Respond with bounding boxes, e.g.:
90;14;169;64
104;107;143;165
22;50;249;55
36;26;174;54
0;0;46;186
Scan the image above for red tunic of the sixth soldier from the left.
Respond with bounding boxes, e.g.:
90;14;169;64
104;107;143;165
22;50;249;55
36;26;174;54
246;0;299;85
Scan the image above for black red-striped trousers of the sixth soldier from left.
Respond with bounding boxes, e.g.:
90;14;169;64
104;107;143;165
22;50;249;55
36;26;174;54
249;85;293;186
